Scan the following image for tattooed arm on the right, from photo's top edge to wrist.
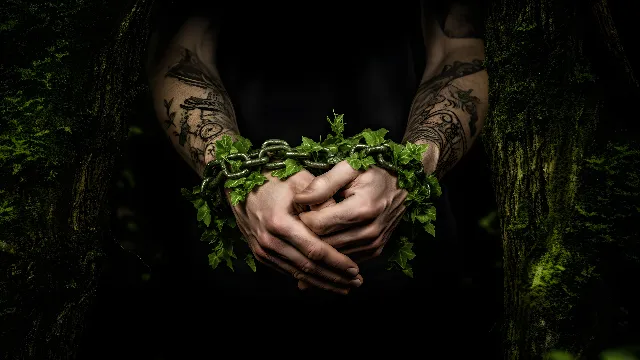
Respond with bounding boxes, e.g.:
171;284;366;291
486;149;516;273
404;0;488;178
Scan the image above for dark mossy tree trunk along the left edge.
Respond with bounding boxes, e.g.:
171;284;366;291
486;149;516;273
0;0;153;359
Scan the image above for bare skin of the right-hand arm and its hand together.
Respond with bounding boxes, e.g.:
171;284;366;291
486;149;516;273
294;2;488;289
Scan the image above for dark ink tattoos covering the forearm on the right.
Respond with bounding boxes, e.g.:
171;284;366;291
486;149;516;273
404;60;484;177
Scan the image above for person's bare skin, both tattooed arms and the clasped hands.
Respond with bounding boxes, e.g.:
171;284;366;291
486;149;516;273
148;0;488;294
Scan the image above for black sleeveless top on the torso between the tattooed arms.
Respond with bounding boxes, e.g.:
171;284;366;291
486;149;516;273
218;1;424;146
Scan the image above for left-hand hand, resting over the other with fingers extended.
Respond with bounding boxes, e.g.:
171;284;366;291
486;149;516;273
227;170;362;294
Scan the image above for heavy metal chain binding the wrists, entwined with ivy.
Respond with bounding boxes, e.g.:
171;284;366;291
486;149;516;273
200;139;398;194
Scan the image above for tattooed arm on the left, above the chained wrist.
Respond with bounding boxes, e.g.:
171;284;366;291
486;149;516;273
147;18;238;176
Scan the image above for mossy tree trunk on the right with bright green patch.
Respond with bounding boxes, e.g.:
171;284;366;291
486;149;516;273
484;0;640;359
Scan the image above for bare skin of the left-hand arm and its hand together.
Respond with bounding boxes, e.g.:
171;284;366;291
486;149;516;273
147;18;363;294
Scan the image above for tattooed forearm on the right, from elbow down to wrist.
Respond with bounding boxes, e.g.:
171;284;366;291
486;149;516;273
404;52;488;178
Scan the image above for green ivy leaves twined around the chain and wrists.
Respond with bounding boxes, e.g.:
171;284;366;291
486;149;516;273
182;114;441;277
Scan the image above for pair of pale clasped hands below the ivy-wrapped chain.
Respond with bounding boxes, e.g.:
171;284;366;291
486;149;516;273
233;161;407;294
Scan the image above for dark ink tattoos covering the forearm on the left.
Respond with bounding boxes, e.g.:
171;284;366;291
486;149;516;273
164;49;238;167
